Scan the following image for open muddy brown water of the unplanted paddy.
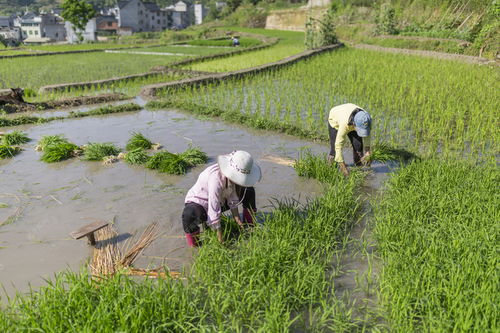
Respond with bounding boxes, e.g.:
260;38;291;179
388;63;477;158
0;110;326;295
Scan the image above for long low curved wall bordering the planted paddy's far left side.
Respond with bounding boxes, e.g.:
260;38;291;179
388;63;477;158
141;43;344;99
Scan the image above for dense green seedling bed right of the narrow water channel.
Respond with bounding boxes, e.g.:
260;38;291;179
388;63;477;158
375;158;500;332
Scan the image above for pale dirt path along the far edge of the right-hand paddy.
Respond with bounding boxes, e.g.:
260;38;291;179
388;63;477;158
349;44;499;65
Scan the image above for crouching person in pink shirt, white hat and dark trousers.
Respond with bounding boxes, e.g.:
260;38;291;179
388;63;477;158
182;150;261;247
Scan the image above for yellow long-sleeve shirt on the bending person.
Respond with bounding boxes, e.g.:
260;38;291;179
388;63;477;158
328;103;370;163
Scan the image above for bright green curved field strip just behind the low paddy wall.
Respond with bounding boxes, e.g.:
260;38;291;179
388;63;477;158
185;27;305;72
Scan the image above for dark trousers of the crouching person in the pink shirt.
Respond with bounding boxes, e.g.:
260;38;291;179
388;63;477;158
182;187;256;234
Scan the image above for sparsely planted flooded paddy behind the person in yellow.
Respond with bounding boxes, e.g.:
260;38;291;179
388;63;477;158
163;49;500;157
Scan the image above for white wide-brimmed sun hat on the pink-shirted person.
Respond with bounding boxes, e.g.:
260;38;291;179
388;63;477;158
217;150;262;187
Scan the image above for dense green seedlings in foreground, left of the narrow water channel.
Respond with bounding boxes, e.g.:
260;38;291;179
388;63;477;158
0;153;368;332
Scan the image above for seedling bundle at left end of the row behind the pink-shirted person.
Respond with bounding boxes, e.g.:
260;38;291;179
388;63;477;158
35;135;81;163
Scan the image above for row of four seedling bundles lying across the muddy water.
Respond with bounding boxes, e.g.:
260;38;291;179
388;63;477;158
35;133;208;175
